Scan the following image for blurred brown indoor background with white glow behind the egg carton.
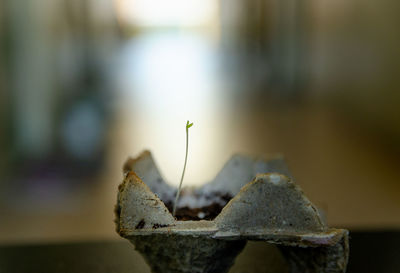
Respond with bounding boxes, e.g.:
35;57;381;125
0;0;400;244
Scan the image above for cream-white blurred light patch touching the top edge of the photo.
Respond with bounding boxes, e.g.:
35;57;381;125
115;0;218;27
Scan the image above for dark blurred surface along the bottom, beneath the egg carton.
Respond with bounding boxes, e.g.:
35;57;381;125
0;231;400;273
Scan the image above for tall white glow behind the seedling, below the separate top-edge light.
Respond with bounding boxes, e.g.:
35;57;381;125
114;32;227;185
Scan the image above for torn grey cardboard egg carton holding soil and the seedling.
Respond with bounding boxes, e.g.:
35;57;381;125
115;151;349;273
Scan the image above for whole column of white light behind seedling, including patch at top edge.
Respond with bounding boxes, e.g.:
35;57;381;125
111;0;229;185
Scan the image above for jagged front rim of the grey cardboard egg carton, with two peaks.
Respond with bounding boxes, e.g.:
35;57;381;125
116;151;348;246
